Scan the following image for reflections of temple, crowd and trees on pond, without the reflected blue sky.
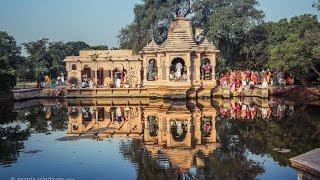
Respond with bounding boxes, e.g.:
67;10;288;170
0;98;320;179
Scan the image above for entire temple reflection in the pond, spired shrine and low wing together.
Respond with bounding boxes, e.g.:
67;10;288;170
66;100;218;172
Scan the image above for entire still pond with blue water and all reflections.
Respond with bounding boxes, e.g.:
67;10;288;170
0;98;320;180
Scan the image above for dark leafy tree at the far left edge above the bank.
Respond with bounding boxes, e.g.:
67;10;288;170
0;31;22;91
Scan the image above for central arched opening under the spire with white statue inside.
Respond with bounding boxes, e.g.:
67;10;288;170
170;58;187;81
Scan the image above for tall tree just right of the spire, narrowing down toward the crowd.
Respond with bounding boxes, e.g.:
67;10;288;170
204;0;264;68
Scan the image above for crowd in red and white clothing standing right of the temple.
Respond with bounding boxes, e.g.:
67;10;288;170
218;70;294;91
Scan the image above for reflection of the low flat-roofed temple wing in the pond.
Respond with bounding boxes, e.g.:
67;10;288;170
67;106;143;138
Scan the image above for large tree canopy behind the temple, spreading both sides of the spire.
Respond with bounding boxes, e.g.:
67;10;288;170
119;0;263;68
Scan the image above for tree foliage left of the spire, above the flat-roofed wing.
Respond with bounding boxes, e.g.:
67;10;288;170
118;0;195;52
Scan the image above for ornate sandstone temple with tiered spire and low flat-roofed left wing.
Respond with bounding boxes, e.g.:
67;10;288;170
65;17;218;97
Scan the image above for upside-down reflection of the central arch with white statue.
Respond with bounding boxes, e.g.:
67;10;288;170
170;120;188;142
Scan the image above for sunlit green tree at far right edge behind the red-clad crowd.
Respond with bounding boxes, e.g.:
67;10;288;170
267;14;320;83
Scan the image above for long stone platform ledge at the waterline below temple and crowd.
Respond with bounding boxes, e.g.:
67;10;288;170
12;86;269;100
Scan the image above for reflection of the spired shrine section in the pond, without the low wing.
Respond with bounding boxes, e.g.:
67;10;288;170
144;100;218;172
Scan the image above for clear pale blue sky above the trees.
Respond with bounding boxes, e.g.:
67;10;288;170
0;0;318;47
